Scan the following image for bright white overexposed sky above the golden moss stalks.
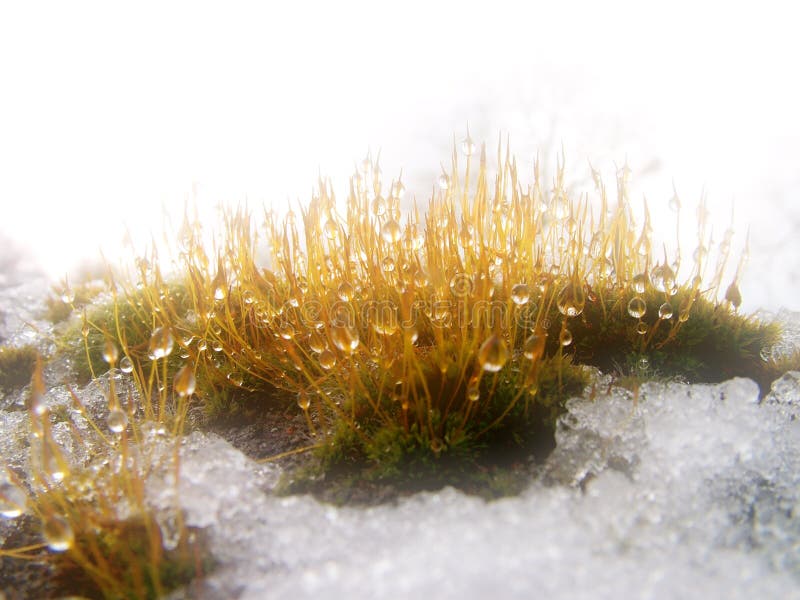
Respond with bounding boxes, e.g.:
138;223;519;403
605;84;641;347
0;1;800;309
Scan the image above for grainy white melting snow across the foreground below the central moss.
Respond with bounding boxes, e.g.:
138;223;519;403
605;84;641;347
156;373;800;599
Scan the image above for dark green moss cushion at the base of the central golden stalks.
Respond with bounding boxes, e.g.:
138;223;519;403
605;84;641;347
283;356;590;503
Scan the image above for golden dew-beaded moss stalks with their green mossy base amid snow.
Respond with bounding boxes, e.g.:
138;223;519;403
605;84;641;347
0;138;798;597
